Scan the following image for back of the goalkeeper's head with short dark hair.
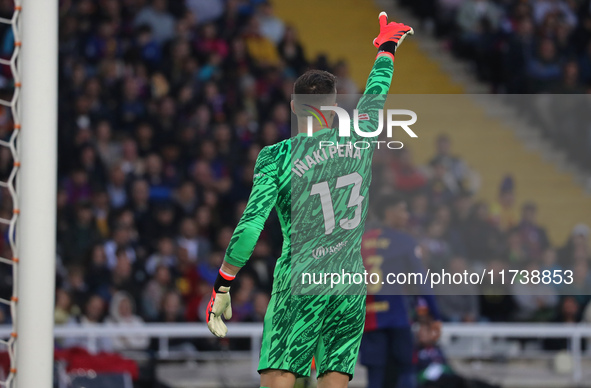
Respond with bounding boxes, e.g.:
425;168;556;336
293;70;337;116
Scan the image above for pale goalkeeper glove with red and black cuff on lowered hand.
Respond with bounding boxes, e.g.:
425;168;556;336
205;269;236;338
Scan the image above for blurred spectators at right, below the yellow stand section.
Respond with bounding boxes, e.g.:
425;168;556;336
369;139;591;346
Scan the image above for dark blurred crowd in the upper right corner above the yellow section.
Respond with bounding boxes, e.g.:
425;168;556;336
398;0;591;172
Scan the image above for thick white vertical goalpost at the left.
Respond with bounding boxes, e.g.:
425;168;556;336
13;0;58;388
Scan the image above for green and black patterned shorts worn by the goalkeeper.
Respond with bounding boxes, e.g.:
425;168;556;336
258;289;365;379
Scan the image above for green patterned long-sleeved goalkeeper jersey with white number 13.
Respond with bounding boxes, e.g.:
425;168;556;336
225;55;394;293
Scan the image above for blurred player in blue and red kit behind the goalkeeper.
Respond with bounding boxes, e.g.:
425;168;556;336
360;195;441;388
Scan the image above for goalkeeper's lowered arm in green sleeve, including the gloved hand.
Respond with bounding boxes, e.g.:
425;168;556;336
206;147;278;337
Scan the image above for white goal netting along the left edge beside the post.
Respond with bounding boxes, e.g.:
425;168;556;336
0;0;21;387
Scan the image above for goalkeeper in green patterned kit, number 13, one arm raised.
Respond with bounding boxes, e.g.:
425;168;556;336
207;12;414;388
